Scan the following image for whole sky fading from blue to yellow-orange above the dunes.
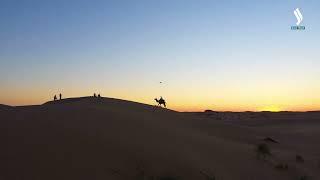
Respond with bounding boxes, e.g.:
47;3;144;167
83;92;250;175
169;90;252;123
0;0;320;111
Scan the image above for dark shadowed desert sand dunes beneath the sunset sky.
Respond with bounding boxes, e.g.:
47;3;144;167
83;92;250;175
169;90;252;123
0;97;320;180
